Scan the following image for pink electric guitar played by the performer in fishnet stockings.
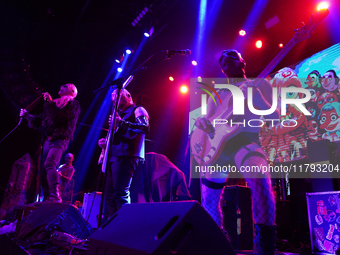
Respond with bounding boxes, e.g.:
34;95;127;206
190;10;329;165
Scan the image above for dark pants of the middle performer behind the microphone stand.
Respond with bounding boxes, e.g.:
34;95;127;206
105;156;138;216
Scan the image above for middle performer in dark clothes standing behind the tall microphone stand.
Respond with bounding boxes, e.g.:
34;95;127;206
98;89;149;216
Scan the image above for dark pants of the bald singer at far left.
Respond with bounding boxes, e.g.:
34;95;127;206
41;140;69;199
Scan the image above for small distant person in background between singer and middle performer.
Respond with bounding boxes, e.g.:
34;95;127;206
57;153;75;201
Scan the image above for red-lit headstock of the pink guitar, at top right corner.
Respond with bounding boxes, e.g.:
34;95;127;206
293;9;329;43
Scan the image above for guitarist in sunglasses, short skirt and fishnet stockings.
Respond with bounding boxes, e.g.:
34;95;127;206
195;50;279;254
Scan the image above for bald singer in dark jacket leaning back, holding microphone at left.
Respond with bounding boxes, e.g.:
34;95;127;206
20;83;80;203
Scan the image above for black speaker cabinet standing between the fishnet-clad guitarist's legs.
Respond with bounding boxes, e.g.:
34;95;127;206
221;186;254;250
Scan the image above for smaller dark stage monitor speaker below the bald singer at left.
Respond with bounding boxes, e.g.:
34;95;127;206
16;203;93;242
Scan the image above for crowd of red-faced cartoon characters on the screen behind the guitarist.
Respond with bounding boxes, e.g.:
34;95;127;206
260;56;340;161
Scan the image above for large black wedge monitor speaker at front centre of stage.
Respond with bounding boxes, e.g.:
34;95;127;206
87;201;235;255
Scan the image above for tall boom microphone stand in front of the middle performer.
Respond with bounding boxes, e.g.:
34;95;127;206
93;53;174;228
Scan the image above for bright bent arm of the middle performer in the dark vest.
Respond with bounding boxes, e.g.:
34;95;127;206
119;106;150;135
